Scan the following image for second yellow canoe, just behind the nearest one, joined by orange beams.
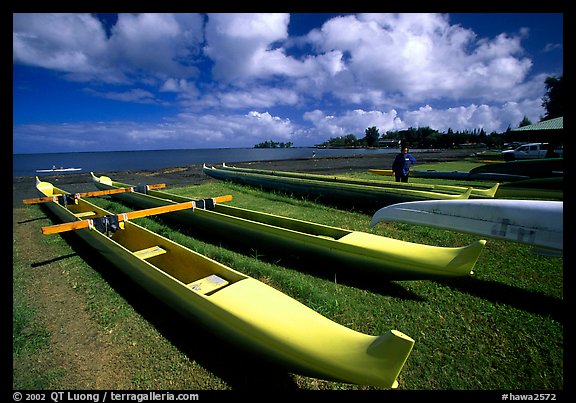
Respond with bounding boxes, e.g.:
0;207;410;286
92;173;486;280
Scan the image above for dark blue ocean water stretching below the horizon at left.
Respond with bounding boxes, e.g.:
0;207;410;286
12;147;398;176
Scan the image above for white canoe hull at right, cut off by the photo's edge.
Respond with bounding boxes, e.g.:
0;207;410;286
370;199;563;256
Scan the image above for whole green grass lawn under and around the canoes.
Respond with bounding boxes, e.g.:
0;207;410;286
13;161;564;390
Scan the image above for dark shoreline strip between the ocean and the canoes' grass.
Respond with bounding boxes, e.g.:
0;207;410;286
12;150;474;207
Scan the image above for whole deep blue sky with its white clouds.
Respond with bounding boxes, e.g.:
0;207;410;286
13;13;563;153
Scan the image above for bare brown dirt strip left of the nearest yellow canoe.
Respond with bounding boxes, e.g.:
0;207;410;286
13;208;132;389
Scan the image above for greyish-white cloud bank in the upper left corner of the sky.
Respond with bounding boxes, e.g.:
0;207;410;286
13;13;203;83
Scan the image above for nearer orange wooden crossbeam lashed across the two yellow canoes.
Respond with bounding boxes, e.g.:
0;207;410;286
42;195;232;235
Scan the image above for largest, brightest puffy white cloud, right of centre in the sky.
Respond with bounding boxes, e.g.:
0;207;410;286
308;13;531;105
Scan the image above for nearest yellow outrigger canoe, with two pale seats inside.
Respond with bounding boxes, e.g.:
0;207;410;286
30;178;414;388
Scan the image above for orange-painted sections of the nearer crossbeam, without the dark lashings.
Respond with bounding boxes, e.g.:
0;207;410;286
42;195;232;235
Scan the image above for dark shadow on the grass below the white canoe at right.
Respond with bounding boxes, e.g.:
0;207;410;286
437;277;564;321
